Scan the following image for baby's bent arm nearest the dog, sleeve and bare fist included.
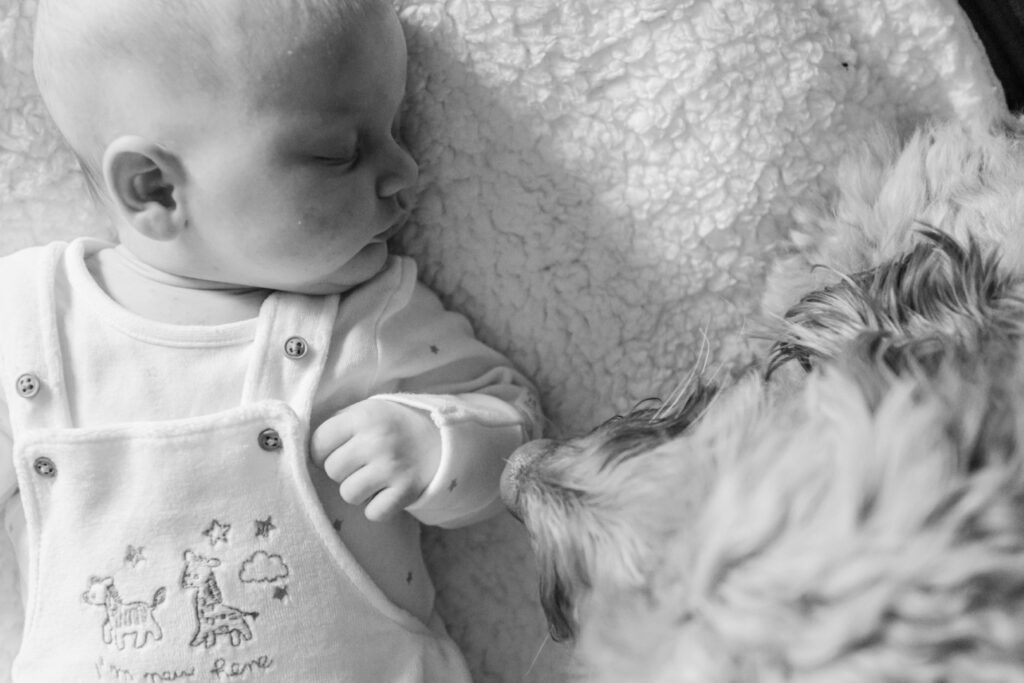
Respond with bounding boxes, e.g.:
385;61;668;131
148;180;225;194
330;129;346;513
311;259;540;526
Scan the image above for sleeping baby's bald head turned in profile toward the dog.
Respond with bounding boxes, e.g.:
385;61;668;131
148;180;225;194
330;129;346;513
35;0;417;294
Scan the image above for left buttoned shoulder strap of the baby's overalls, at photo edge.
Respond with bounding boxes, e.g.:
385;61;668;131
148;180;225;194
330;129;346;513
0;242;72;434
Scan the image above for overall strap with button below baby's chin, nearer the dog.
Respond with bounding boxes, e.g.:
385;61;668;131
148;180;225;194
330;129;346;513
242;292;340;422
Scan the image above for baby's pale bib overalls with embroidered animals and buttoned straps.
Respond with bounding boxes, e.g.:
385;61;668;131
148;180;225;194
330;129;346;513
0;245;469;683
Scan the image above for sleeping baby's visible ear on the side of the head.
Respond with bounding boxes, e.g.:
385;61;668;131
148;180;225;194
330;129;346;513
103;135;187;241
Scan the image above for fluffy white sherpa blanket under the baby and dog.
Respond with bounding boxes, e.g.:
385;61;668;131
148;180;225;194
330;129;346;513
0;0;1002;683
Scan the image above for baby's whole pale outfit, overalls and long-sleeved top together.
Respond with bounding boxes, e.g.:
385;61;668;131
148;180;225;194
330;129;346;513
0;240;536;683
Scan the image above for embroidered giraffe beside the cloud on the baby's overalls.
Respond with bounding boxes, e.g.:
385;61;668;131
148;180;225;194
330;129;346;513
181;550;259;647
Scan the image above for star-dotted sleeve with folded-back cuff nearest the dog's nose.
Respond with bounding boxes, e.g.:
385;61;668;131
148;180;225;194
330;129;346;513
323;258;540;527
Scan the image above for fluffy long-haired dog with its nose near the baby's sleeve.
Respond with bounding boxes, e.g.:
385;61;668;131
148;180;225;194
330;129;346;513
503;122;1024;683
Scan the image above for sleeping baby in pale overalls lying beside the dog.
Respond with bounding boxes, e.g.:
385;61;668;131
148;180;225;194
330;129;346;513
0;0;539;683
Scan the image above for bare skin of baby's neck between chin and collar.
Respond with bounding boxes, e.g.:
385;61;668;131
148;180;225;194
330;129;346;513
86;246;269;325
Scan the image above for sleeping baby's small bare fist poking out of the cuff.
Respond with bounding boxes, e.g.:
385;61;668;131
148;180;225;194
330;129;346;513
309;399;441;521
